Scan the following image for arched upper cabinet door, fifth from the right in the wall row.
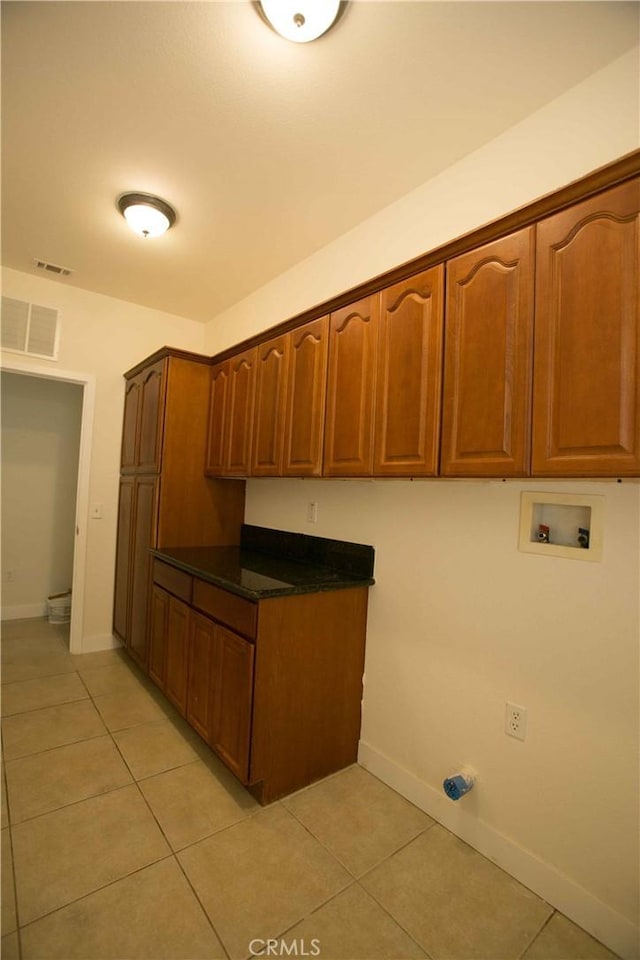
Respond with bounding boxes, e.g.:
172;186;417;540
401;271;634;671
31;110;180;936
282;316;329;477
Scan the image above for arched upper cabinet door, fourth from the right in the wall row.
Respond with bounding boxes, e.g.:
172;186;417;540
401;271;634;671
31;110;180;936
323;295;380;477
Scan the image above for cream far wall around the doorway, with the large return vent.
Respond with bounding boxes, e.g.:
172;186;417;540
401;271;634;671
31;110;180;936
2;268;204;651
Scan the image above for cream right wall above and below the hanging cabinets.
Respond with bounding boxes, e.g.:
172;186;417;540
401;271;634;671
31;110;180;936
206;49;640;957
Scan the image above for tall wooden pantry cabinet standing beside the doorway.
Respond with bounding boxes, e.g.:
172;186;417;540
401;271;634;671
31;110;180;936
113;348;244;669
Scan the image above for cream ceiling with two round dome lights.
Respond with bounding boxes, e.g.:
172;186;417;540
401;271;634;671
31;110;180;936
2;0;638;321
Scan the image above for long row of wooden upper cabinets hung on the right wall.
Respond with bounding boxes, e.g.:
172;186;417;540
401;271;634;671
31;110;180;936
201;168;640;477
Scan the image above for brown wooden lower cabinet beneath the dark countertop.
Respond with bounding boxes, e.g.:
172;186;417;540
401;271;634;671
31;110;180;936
148;559;367;804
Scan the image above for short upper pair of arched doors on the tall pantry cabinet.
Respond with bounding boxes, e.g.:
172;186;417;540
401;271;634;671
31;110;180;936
120;360;166;473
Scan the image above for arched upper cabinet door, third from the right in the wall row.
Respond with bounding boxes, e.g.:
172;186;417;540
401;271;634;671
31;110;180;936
373;265;444;476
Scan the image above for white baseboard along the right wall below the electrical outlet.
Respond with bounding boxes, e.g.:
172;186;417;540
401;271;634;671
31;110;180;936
358;740;640;960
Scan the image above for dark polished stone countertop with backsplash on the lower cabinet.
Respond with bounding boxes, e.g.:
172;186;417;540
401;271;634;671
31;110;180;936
151;525;375;600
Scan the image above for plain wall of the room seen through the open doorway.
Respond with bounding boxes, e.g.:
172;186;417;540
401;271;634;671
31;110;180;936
2;373;82;619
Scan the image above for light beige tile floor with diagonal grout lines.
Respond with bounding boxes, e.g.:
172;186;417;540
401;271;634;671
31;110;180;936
2;620;614;960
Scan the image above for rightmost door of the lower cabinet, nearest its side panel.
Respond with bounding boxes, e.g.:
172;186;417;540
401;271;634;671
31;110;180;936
210;626;254;783
